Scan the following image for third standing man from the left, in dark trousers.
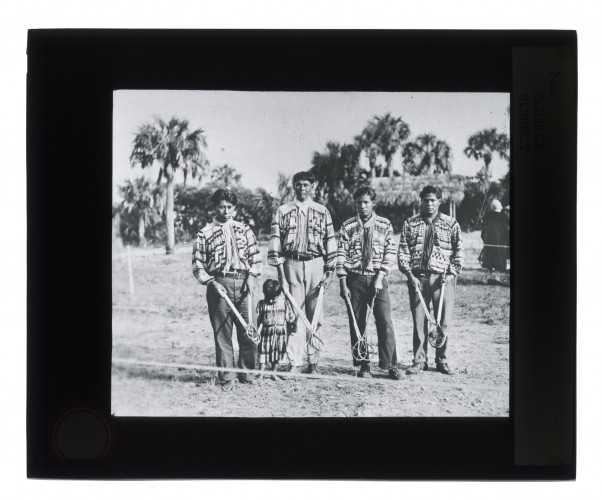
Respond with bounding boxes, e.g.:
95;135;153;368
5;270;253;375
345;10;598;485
337;187;400;380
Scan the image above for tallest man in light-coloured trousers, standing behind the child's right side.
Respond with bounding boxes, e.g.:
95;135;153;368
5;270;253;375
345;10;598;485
268;172;337;373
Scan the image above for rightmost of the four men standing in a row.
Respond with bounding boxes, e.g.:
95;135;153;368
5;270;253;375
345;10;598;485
397;186;464;375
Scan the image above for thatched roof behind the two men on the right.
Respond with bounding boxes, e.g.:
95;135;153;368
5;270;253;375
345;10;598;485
370;174;464;207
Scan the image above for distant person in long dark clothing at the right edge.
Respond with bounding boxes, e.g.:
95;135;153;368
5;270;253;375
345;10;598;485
479;200;509;286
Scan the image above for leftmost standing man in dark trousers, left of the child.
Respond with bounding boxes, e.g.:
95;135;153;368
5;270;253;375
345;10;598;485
192;189;262;391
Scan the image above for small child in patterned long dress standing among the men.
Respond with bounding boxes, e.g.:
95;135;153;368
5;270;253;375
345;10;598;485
257;280;295;381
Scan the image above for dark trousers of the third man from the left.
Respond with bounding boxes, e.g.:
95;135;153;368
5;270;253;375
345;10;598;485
347;273;397;370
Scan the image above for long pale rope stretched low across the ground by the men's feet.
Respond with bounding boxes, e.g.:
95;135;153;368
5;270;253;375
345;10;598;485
112;358;508;391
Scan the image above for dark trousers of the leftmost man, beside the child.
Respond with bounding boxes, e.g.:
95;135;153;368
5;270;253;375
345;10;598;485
207;278;257;382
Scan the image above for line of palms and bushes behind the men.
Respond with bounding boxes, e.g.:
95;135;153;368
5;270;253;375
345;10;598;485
113;114;509;253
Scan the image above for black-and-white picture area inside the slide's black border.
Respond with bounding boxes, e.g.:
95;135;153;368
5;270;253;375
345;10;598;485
111;90;511;418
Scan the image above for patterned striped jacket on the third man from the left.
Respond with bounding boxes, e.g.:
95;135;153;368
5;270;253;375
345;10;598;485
337;214;395;278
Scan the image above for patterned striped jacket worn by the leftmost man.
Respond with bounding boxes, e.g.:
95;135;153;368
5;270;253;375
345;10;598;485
192;219;262;285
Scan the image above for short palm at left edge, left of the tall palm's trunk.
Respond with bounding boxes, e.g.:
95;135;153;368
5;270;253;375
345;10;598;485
119;177;160;246
